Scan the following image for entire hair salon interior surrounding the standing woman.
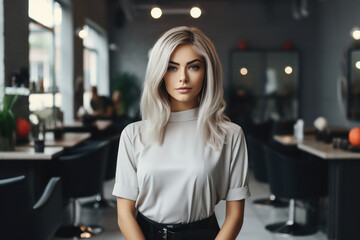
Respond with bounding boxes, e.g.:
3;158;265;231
0;0;360;240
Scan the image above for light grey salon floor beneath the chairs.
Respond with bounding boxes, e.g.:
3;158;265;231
52;171;327;240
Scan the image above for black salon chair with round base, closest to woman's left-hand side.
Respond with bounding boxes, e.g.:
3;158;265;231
56;141;109;238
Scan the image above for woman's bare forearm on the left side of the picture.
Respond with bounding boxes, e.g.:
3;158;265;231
117;197;145;240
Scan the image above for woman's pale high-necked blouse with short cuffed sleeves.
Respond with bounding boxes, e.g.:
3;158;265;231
113;108;250;224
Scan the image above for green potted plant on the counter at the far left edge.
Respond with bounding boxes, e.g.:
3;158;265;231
0;95;19;151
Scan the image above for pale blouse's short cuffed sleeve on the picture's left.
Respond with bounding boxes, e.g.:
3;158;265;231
112;126;139;201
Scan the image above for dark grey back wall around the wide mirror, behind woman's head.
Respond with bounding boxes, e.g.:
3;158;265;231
110;0;360;127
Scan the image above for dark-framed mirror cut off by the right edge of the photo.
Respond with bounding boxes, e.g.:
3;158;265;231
347;49;360;120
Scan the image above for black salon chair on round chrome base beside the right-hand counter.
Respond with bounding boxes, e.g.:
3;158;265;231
264;143;327;236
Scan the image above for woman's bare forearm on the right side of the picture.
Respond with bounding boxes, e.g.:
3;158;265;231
215;199;245;240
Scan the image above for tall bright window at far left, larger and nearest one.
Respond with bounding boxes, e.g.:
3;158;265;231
29;0;62;125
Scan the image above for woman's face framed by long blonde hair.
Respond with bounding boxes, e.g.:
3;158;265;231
164;44;205;112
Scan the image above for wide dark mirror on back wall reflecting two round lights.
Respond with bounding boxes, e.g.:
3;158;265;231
229;50;299;123
